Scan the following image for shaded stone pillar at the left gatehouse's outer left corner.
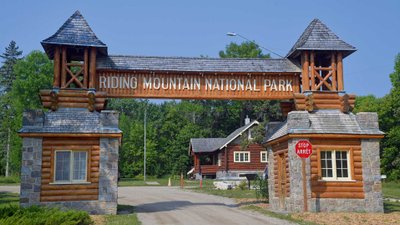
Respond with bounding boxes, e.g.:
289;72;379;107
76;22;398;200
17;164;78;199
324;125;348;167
20;138;42;207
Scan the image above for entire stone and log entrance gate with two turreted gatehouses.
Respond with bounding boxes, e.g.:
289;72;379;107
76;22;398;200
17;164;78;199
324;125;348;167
20;11;383;214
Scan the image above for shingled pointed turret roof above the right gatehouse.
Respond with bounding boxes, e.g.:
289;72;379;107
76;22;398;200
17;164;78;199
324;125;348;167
286;19;356;58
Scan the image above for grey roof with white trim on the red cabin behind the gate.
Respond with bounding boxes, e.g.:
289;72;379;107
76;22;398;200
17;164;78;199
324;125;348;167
190;120;259;152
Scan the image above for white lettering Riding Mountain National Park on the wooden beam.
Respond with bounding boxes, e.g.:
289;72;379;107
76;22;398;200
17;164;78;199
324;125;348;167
99;74;293;92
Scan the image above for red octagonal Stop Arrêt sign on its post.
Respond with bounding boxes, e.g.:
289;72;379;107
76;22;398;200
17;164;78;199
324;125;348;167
295;140;312;212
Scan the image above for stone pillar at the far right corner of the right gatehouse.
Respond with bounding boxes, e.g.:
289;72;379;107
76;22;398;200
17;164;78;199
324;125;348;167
361;139;383;212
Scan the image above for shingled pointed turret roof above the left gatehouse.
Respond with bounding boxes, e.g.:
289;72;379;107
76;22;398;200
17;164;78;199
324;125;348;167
41;11;107;59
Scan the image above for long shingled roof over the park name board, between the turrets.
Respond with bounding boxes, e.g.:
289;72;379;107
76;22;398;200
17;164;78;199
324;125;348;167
96;55;301;73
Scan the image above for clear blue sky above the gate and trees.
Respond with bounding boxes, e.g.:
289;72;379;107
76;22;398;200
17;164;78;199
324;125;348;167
0;0;400;97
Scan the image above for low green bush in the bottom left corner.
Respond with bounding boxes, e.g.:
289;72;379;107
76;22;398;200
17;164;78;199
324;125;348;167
0;206;93;225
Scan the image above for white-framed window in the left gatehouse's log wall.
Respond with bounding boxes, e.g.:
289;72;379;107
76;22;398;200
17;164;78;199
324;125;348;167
54;150;88;183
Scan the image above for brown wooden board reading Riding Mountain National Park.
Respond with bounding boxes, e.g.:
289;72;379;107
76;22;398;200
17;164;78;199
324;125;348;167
96;71;300;100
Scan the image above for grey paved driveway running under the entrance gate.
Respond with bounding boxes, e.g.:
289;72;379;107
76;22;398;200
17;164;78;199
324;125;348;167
0;186;291;225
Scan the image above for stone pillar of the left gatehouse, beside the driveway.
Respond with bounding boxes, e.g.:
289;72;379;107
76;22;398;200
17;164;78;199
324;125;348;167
99;137;119;214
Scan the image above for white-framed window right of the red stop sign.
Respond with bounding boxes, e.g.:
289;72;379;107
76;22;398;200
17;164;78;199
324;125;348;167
320;150;351;181
